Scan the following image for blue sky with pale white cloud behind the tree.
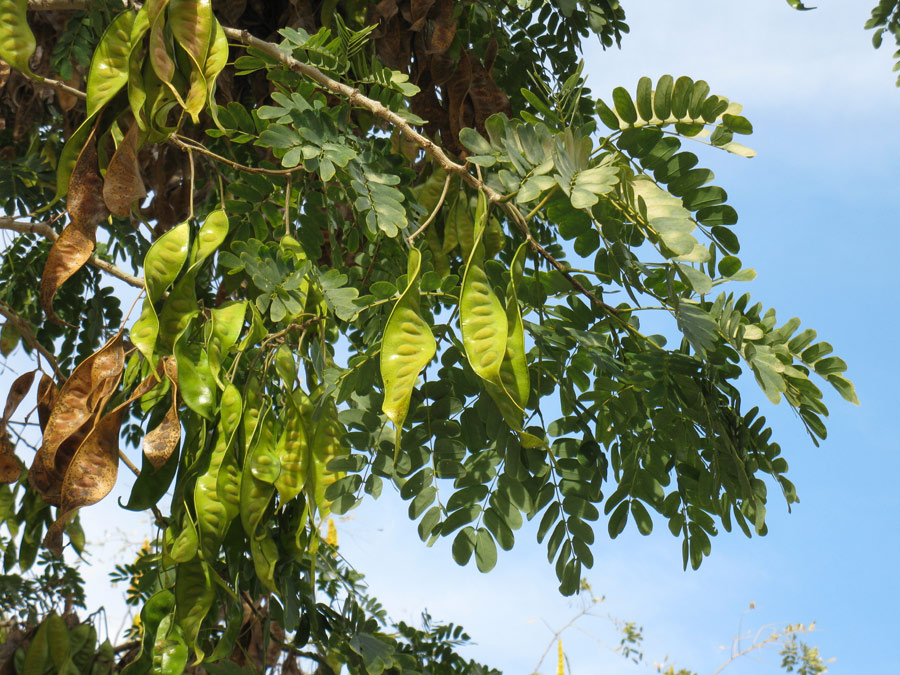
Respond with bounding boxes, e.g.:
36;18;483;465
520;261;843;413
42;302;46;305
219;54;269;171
3;0;900;675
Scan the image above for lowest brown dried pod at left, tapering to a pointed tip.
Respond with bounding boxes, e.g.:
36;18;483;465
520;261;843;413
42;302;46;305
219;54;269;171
44;407;122;555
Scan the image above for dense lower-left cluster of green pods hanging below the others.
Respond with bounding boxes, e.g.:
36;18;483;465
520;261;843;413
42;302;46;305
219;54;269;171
156;380;345;672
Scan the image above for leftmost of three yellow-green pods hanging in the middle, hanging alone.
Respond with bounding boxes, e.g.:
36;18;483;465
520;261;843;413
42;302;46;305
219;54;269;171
381;248;437;451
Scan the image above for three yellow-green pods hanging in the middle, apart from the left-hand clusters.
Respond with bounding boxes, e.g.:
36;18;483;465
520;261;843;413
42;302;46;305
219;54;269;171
381;194;536;452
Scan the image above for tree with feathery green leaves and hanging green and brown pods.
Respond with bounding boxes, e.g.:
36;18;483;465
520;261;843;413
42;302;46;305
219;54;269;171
0;0;868;675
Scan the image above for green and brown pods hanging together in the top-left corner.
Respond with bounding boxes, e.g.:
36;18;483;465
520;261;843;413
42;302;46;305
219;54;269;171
10;0;228;321
